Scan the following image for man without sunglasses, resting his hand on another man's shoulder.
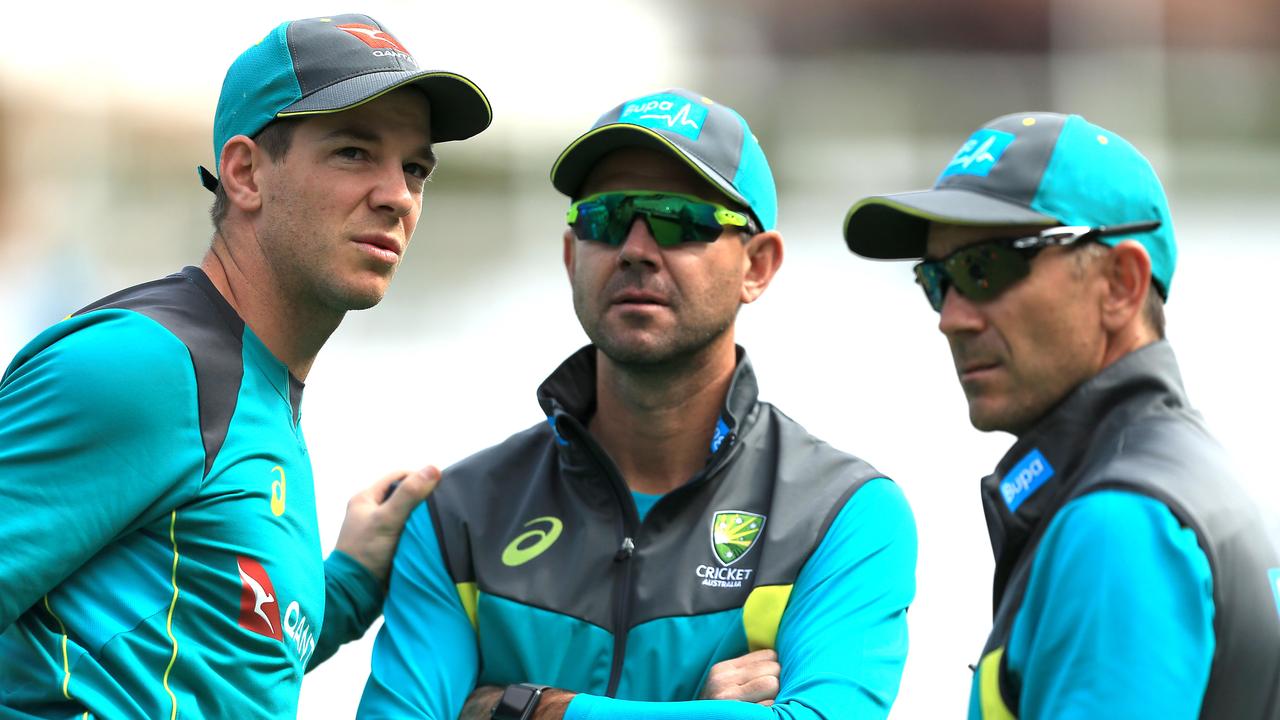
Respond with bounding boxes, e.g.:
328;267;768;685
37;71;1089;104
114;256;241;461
0;15;489;719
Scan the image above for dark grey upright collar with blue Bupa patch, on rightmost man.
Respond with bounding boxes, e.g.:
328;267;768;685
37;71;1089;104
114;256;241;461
982;341;1192;603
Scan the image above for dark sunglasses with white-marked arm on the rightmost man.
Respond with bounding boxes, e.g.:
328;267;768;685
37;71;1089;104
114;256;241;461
915;220;1160;313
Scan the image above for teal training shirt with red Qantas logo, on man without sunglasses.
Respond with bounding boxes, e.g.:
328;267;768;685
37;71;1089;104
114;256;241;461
0;268;380;719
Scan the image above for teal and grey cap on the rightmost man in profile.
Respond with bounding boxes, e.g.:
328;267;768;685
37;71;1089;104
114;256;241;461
845;113;1178;299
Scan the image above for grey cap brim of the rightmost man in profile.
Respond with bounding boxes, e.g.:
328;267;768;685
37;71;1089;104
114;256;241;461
845;188;1059;260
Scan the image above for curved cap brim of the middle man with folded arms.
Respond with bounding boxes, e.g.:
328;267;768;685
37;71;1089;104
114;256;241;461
552;123;747;219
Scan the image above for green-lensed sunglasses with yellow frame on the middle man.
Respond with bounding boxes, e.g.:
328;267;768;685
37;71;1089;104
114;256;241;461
566;190;759;247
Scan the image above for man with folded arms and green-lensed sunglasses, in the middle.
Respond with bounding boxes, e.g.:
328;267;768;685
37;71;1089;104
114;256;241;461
361;90;915;720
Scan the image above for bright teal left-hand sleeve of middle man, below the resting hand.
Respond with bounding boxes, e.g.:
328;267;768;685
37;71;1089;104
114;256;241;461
356;502;480;720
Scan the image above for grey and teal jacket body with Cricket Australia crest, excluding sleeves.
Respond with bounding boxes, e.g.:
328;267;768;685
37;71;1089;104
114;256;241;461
429;346;881;701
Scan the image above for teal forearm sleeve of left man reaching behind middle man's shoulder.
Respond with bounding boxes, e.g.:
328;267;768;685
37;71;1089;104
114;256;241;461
307;550;383;673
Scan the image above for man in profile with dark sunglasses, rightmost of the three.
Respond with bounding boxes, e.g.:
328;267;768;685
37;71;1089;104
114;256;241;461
845;113;1280;720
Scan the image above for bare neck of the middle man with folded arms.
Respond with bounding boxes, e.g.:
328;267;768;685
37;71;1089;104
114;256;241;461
589;332;737;495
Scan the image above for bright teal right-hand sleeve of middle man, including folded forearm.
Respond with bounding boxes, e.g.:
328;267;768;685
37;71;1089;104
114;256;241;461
564;478;916;720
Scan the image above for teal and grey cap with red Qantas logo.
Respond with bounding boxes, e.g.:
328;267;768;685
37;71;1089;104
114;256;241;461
198;14;493;191
